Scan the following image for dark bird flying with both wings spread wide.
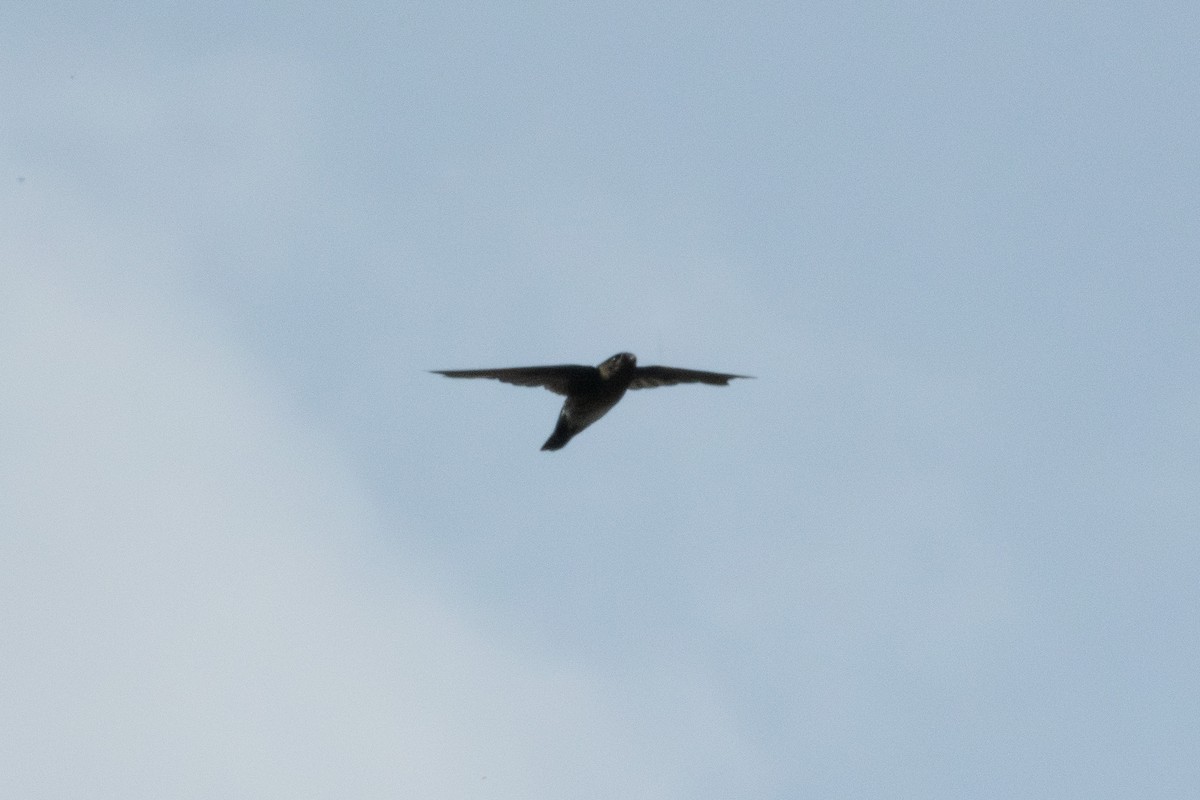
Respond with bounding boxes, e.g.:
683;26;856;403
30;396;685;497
432;353;750;450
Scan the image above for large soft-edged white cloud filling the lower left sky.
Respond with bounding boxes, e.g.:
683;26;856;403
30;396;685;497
0;247;748;798
